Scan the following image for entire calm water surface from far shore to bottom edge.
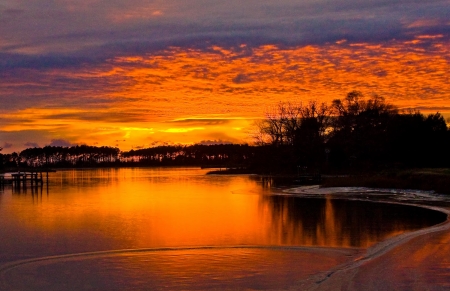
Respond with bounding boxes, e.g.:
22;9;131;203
0;168;445;290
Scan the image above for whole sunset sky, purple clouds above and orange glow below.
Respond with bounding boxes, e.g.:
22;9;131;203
0;0;450;153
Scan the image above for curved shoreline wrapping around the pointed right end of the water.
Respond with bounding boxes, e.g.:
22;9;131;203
283;185;450;290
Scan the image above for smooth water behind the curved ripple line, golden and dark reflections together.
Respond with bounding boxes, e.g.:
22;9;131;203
0;169;439;253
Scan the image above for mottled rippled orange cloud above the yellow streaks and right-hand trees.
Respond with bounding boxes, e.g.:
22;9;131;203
107;36;449;118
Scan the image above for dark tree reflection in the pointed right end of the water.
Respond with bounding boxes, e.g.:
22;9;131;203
261;195;446;247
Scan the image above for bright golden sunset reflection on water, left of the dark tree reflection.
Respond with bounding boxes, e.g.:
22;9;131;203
1;169;264;256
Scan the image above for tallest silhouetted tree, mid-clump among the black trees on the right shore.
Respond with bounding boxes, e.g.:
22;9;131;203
327;91;398;167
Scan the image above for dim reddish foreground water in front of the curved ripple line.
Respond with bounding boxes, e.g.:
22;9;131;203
0;247;362;290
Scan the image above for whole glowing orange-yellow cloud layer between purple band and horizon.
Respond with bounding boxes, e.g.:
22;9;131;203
0;35;450;150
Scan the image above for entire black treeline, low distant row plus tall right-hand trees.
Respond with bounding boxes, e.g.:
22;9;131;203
0;91;450;173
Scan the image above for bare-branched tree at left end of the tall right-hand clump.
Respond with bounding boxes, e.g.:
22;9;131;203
254;101;330;172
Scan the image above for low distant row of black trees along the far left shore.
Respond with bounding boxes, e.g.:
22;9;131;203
3;144;253;167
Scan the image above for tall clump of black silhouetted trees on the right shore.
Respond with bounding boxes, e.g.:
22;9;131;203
255;91;450;171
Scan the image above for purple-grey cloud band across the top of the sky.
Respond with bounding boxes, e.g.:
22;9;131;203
0;0;450;70
